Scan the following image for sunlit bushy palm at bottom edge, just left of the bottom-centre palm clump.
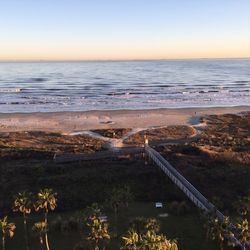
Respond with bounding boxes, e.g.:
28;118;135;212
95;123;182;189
87;216;110;250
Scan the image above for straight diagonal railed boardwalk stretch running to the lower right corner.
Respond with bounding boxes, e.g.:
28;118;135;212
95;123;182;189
145;144;250;250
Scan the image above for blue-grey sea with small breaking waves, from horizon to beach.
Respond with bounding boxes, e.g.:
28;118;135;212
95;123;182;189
0;59;250;112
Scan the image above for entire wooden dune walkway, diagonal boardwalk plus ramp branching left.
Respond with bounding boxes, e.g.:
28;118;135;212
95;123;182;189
54;137;250;250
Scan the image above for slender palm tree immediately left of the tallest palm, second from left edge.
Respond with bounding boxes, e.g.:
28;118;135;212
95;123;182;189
13;192;32;250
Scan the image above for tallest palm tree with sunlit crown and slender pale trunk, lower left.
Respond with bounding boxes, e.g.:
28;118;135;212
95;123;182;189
35;188;57;250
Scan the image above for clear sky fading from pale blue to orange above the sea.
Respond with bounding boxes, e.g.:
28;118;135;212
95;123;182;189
0;0;250;60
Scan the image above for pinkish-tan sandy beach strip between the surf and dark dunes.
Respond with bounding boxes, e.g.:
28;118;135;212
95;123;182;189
0;106;250;133
